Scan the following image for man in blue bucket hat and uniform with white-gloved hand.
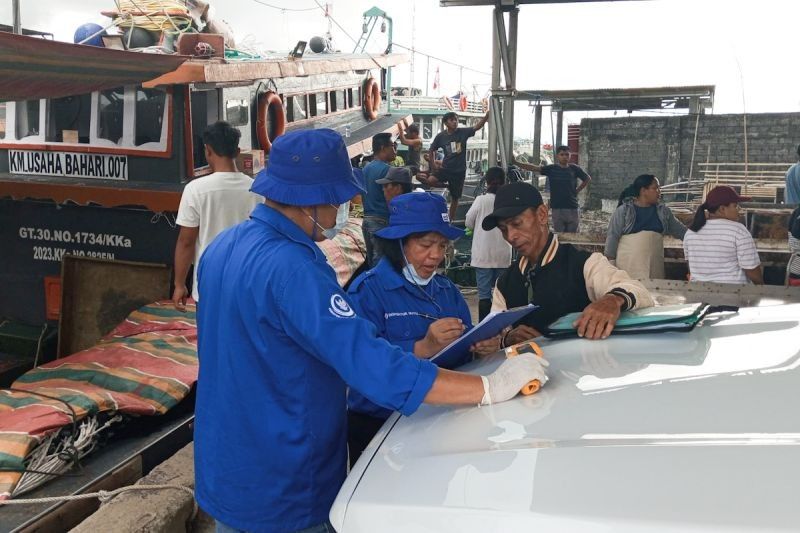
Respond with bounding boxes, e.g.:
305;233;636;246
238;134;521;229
194;128;545;531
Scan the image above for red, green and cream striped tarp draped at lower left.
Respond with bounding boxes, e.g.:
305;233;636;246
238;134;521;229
0;301;198;499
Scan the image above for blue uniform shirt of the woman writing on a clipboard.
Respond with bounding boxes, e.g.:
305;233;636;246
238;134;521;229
347;257;472;418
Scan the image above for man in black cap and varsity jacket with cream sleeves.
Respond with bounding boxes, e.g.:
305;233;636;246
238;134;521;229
482;182;654;340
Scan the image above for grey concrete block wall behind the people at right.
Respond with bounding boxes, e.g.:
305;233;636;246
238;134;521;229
580;113;800;208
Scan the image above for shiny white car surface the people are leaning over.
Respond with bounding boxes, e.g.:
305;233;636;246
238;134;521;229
330;304;800;533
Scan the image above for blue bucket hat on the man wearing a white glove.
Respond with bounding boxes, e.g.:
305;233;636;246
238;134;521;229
250;128;364;205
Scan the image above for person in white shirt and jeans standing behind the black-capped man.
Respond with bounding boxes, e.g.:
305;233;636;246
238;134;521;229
466;167;511;320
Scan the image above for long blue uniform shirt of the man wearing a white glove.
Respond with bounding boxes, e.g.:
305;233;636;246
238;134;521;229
194;204;437;532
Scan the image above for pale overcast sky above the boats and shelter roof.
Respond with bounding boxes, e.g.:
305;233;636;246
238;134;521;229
0;0;800;139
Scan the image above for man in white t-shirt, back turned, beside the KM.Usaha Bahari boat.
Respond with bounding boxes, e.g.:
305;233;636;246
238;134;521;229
172;121;264;311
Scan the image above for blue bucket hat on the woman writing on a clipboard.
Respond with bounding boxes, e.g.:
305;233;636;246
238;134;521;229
375;192;464;241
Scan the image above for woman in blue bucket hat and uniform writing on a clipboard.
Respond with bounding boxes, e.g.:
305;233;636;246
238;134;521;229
347;192;500;463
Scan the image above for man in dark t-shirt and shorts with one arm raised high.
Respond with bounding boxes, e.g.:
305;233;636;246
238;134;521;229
420;111;489;220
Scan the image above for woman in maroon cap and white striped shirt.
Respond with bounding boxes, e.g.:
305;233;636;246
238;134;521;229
683;185;764;285
